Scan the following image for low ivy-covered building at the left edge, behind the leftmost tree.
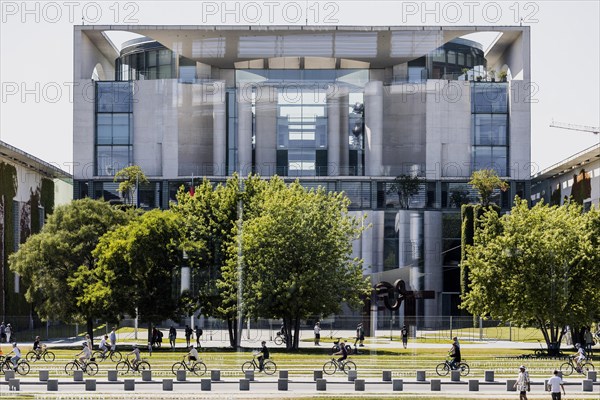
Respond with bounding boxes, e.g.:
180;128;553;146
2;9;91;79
0;141;73;318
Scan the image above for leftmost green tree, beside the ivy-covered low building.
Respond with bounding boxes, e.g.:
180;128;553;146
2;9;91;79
9;198;132;342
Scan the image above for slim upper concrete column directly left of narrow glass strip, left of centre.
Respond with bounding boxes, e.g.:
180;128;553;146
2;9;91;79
212;82;227;176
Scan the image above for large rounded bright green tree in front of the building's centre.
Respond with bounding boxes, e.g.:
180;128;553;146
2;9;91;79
239;178;370;349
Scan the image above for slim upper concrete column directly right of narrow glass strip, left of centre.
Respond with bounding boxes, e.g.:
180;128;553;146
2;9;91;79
236;94;252;176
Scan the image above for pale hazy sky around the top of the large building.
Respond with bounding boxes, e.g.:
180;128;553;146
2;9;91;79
0;0;600;174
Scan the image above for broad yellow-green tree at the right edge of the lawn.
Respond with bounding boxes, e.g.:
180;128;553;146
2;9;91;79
461;200;600;352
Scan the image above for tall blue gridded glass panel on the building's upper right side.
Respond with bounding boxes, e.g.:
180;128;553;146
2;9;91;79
471;82;509;176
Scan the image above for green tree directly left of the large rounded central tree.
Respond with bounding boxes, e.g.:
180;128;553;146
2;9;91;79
171;174;266;348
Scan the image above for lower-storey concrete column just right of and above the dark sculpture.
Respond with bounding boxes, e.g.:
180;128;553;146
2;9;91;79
423;211;444;322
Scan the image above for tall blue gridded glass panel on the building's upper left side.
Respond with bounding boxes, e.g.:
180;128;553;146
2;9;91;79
95;81;133;176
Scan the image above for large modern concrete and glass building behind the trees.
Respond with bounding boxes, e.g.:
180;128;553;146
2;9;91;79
73;26;531;329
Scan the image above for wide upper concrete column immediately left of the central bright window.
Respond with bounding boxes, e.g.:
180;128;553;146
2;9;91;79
255;86;277;176
